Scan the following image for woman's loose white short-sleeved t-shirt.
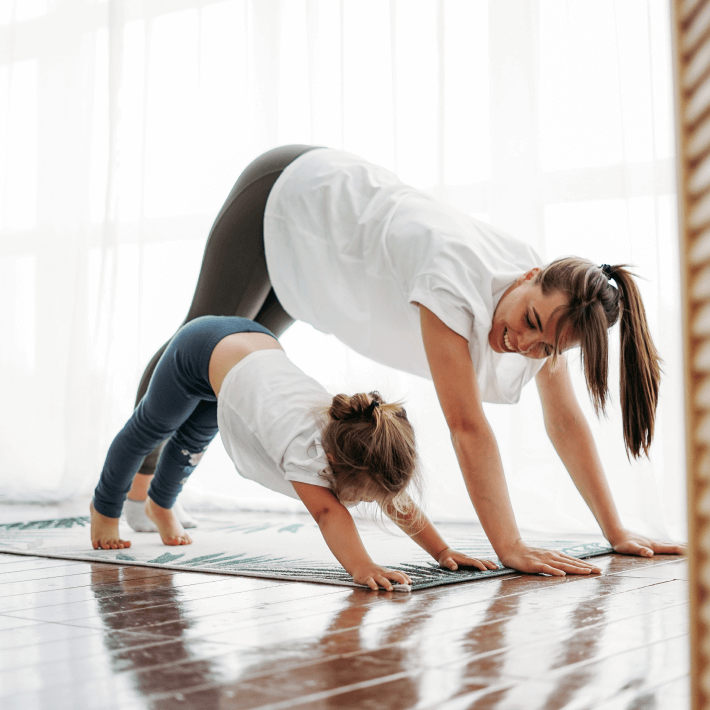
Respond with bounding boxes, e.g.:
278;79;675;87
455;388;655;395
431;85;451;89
264;148;544;404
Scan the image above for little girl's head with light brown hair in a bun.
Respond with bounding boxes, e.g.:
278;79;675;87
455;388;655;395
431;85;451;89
322;392;418;513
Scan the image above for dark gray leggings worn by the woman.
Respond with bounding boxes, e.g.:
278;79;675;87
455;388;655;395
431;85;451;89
136;145;317;475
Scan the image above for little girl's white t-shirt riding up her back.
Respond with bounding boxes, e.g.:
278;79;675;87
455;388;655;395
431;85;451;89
217;349;355;507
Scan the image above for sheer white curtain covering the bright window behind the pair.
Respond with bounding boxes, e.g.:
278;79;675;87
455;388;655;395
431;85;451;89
0;0;684;534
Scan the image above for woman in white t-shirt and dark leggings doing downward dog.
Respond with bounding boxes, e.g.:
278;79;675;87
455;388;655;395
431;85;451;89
125;146;683;575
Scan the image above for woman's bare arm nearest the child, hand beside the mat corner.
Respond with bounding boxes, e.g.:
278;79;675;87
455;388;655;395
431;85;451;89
419;305;599;576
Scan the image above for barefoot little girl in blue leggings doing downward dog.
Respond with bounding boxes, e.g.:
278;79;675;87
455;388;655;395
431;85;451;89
91;316;552;590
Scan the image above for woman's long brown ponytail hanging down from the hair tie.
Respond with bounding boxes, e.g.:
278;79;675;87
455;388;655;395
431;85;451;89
609;266;661;456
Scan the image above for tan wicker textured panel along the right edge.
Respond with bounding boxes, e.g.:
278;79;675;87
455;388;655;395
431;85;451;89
672;0;710;710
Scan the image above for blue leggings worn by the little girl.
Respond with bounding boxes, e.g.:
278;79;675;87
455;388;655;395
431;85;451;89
94;316;276;518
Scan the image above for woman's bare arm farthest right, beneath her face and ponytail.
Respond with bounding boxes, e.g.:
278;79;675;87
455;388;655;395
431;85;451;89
535;355;684;557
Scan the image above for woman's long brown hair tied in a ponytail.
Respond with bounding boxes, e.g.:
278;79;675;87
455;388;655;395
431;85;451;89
535;257;661;457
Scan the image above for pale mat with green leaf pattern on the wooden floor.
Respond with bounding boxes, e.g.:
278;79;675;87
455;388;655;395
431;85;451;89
0;515;611;591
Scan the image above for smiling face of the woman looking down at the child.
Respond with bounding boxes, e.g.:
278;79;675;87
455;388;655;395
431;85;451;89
488;269;571;360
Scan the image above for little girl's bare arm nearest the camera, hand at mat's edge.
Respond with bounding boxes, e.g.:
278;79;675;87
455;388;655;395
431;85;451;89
291;481;412;592
